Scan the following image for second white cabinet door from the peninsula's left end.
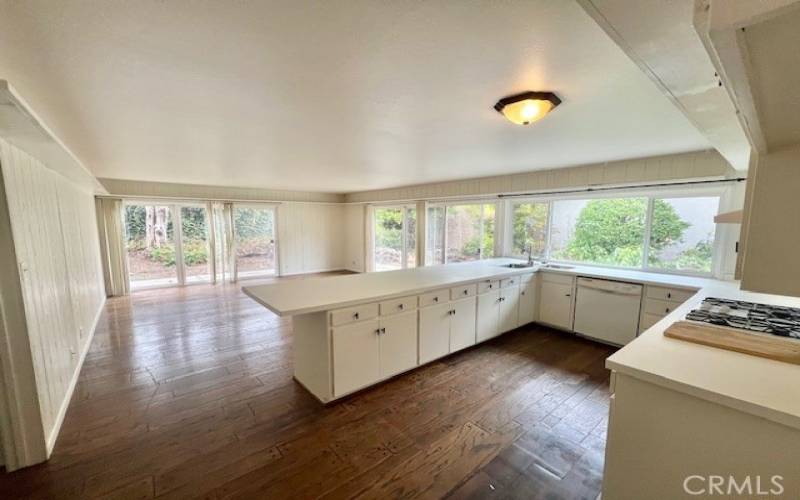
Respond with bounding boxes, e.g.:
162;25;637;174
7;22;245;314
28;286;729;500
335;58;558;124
379;311;417;378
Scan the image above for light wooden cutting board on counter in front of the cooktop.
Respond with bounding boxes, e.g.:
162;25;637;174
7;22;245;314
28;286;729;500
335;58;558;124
664;321;800;365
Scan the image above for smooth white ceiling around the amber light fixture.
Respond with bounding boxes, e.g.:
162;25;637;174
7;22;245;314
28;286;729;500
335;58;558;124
0;0;709;192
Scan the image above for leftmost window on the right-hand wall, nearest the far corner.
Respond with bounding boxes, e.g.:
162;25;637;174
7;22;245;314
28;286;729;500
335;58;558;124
372;206;417;271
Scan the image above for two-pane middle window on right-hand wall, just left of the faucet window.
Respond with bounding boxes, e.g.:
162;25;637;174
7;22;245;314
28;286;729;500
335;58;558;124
427;203;496;264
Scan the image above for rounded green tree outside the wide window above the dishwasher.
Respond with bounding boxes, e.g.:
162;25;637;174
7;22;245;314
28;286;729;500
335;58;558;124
558;198;690;267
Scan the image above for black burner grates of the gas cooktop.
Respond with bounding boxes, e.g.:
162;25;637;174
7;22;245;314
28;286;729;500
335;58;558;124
686;297;800;339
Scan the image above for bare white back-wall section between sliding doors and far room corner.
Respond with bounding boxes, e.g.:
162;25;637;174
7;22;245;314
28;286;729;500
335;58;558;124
278;203;346;275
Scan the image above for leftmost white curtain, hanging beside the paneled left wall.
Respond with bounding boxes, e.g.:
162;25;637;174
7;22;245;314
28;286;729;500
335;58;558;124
95;198;130;297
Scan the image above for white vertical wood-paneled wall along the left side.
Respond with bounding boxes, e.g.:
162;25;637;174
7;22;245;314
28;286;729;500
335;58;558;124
0;139;105;452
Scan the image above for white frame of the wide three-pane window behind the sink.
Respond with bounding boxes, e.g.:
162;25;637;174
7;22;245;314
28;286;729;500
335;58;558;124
503;186;725;278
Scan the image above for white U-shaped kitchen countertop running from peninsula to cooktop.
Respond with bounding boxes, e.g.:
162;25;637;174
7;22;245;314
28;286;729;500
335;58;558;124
243;259;800;429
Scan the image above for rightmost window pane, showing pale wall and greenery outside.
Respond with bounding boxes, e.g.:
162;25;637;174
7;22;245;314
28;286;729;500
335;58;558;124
647;196;719;273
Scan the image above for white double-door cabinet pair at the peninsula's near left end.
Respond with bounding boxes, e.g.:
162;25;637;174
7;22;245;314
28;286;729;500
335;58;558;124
331;311;417;397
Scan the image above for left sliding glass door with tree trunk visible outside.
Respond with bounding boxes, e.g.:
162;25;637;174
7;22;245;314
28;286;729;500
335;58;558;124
125;203;211;290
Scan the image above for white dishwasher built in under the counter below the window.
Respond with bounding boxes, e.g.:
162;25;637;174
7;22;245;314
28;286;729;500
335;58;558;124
573;278;642;345
